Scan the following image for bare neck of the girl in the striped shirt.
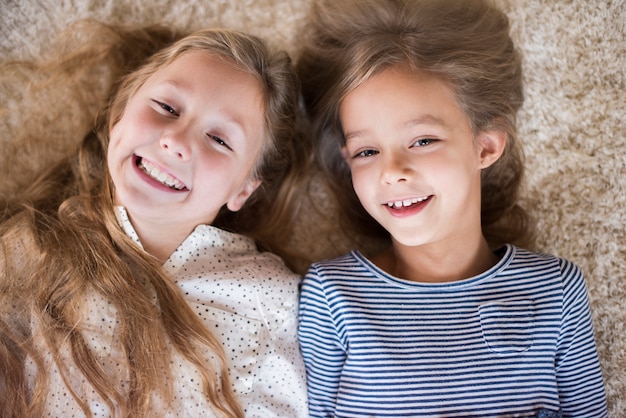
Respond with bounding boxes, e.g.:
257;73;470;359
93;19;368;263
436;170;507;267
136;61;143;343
372;235;498;283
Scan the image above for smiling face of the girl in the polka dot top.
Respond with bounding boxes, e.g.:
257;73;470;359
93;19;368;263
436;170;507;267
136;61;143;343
108;52;265;240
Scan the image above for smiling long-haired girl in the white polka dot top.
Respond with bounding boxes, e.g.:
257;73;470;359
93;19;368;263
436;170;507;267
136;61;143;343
0;22;307;417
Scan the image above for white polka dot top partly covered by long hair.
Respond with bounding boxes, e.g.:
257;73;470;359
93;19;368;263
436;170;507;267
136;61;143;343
28;207;307;418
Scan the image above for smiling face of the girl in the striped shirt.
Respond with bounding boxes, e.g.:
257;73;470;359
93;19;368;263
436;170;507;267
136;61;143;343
340;67;505;251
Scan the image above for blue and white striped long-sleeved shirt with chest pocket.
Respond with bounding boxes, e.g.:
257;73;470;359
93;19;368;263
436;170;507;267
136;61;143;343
299;246;607;418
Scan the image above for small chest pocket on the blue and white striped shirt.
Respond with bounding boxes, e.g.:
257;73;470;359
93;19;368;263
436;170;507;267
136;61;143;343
478;300;533;354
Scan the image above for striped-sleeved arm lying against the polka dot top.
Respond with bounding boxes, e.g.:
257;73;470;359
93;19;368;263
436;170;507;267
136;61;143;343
298;266;346;417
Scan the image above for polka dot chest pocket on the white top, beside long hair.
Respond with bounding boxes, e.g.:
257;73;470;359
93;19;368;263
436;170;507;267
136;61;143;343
202;306;263;394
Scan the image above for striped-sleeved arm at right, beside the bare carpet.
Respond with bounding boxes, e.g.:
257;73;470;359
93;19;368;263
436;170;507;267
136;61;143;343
556;259;607;418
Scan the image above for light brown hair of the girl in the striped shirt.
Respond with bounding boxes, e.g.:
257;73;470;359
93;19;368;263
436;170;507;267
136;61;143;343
297;0;533;247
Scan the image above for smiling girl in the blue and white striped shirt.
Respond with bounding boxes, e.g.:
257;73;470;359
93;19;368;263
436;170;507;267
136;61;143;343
298;0;607;418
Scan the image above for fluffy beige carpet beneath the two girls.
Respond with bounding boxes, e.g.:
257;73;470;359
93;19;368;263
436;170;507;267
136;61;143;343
0;0;626;418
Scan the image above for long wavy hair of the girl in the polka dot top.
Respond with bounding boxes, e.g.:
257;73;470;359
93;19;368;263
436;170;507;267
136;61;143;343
0;22;306;417
